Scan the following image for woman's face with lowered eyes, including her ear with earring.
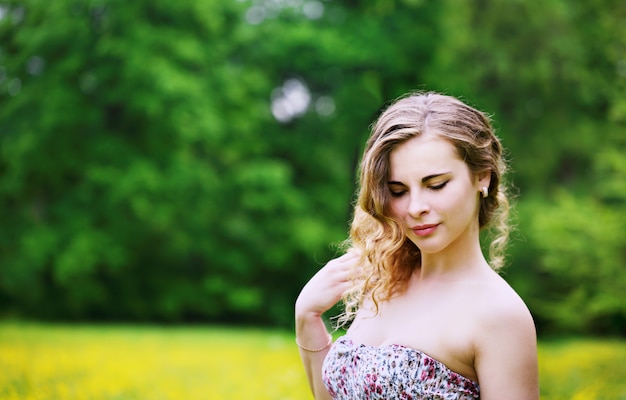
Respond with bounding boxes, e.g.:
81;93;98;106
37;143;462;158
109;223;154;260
388;134;490;254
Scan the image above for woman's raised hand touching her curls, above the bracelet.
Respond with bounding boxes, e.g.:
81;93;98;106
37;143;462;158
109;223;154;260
296;250;360;317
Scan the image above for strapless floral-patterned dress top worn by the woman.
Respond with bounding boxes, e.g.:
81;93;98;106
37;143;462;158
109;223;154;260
322;336;480;400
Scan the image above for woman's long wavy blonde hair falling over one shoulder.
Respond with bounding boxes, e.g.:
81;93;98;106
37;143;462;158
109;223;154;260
338;92;510;326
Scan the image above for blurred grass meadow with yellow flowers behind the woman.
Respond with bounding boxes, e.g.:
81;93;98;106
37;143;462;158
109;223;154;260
0;322;626;400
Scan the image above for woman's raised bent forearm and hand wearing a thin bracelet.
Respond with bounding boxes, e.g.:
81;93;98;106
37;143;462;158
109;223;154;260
295;252;359;400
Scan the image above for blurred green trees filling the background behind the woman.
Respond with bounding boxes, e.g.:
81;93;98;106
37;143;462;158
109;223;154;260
0;0;626;337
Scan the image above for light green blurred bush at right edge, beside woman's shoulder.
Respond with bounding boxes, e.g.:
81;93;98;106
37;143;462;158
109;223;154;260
531;192;626;333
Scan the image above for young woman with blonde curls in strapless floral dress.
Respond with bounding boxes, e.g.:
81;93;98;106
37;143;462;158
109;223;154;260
296;93;539;400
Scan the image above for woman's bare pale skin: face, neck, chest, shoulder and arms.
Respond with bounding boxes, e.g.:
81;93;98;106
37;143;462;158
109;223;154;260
296;134;539;400
